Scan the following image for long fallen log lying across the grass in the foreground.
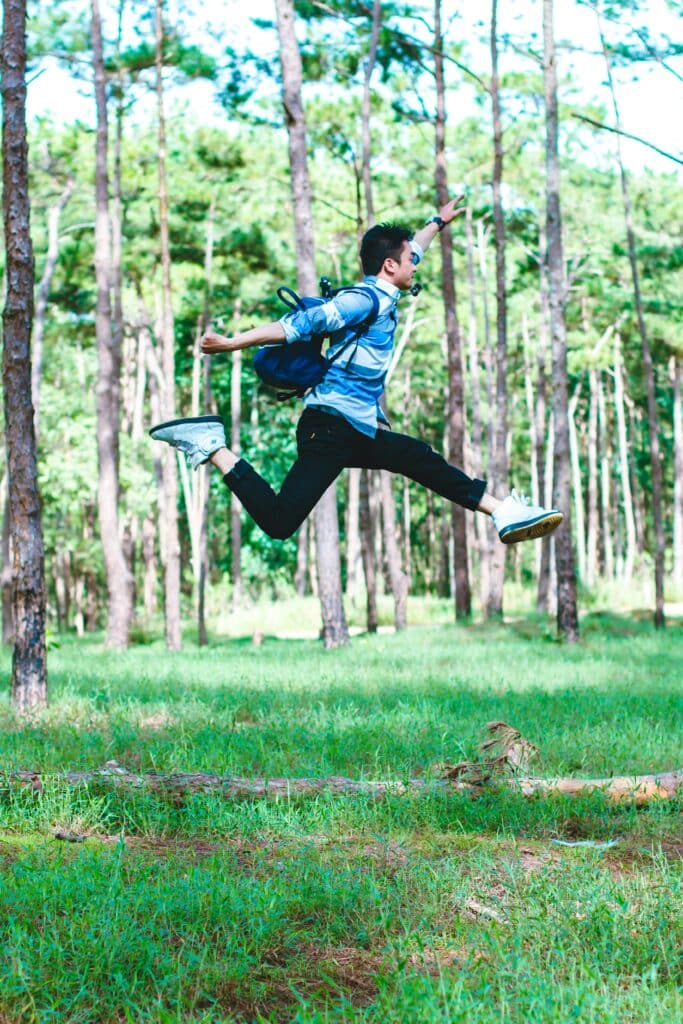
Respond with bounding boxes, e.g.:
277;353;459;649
0;761;683;804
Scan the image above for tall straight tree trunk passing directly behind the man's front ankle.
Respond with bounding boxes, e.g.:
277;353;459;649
486;0;508;618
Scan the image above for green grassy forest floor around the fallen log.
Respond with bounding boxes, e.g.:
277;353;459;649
0;614;683;1024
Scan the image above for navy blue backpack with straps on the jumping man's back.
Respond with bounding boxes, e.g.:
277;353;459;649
254;278;380;400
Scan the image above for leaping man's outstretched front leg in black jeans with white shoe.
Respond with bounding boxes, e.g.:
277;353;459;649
364;430;563;544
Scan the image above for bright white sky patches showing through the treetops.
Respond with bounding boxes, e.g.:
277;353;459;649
29;0;683;172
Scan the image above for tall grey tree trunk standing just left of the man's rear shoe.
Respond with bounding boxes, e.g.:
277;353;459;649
91;0;133;649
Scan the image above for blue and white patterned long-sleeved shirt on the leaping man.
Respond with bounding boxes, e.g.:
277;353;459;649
281;243;424;437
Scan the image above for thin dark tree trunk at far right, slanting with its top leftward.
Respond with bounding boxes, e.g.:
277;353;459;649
595;8;665;629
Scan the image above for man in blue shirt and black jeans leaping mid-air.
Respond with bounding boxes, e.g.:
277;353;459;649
150;196;563;544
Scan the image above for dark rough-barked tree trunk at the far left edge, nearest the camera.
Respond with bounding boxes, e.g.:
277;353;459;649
0;0;47;711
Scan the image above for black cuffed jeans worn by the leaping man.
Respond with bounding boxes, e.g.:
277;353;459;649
223;409;486;540
